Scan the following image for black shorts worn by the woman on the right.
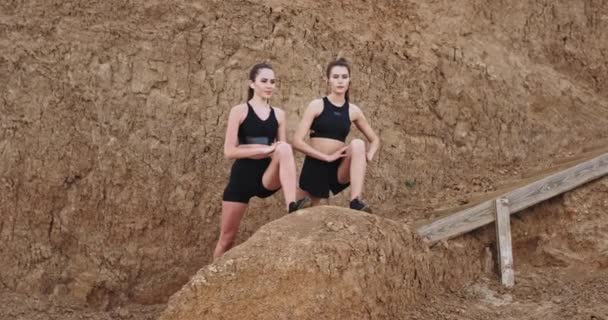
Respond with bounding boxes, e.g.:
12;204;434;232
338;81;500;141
300;156;350;198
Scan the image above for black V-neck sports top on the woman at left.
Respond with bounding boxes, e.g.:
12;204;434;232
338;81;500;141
238;102;279;145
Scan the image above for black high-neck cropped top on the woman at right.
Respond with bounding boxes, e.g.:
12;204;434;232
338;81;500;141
310;97;350;142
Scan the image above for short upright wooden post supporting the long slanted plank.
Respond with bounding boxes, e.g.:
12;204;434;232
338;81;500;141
496;198;515;288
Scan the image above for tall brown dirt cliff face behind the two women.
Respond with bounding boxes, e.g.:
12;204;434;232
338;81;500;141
0;0;608;309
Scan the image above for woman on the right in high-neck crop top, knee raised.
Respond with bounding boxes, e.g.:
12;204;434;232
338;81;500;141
293;58;380;212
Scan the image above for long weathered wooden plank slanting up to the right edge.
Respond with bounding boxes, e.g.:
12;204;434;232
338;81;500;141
418;153;608;242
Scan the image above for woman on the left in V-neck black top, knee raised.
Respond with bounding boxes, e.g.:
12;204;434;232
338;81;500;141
213;63;302;258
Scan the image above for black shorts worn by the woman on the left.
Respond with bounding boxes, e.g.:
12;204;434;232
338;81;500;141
223;158;279;203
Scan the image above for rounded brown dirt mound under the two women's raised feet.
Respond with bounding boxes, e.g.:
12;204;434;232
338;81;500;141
161;206;484;320
